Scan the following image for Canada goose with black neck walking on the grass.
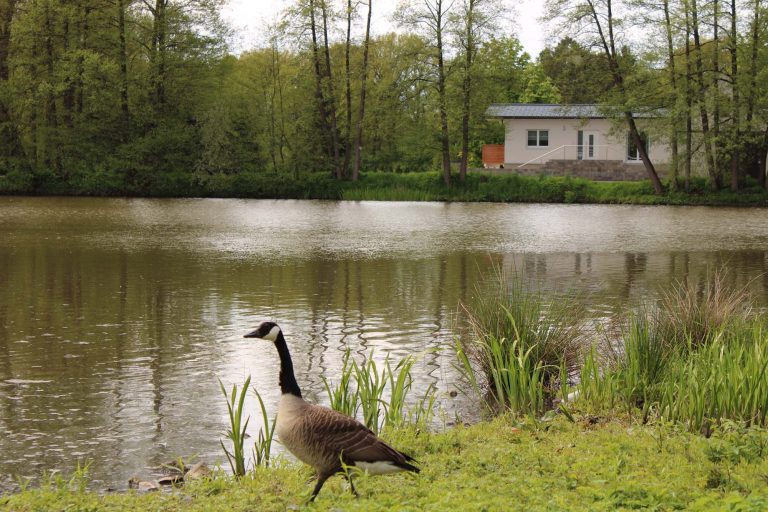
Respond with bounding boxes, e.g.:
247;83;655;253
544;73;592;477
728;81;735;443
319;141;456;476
245;322;419;501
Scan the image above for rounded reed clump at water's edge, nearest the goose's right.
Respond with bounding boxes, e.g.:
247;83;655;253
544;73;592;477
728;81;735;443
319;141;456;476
456;269;587;414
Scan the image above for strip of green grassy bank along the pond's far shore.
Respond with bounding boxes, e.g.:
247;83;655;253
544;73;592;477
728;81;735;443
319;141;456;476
0;171;768;205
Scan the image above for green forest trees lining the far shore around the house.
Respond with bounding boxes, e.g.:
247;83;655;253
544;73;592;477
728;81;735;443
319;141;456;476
0;0;768;195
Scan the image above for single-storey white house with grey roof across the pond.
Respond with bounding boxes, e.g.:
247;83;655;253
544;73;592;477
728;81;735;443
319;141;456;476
486;103;670;179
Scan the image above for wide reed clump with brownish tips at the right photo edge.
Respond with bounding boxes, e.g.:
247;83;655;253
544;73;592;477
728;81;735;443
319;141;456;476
578;273;768;434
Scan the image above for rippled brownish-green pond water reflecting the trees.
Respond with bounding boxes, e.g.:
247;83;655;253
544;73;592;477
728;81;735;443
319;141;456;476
0;197;768;488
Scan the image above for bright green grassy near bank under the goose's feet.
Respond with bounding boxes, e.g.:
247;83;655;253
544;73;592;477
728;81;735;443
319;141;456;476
6;414;768;512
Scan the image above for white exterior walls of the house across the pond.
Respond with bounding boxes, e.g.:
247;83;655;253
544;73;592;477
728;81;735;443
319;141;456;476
504;119;670;165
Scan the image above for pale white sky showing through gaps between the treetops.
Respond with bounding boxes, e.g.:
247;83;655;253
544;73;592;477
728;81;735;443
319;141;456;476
224;0;545;59
